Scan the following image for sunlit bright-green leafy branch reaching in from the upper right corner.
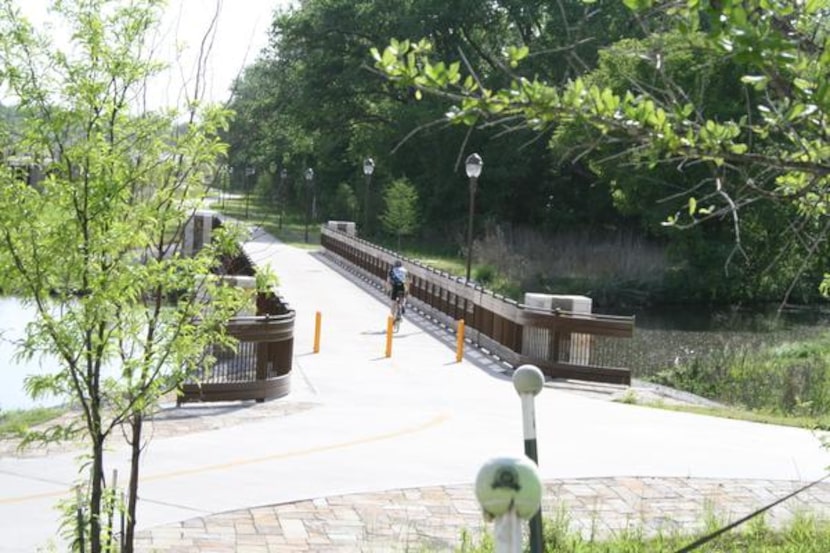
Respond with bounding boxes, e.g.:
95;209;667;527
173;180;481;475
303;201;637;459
373;0;830;302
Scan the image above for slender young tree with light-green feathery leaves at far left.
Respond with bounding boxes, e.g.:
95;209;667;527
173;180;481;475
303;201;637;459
0;0;264;553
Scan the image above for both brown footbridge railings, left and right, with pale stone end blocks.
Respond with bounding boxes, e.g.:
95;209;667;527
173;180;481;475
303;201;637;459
179;212;634;402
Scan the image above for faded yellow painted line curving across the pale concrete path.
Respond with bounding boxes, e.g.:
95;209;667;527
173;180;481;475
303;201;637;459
0;413;450;505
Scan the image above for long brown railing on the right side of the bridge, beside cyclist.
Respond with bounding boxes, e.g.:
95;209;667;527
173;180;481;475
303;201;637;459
321;224;634;384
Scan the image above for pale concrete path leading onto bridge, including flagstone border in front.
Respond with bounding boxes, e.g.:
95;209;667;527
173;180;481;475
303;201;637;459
0;226;830;552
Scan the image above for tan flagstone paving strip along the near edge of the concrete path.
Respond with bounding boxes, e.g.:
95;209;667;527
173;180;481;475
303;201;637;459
136;477;830;553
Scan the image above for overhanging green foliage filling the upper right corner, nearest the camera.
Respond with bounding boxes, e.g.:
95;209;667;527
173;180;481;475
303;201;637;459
372;0;830;302
